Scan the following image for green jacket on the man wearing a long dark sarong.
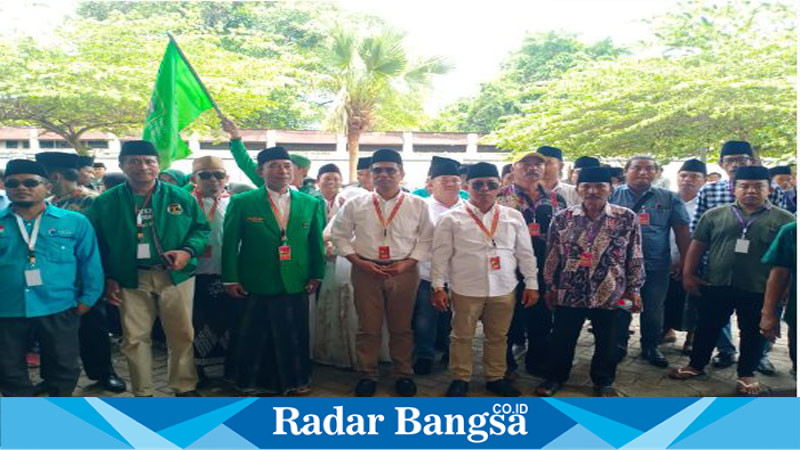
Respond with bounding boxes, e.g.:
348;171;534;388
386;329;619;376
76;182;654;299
222;188;325;295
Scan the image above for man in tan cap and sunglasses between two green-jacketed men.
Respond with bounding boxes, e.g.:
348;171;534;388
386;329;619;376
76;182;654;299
192;156;235;385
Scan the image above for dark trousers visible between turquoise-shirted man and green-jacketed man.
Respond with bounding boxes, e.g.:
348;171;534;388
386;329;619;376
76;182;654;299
78;300;115;380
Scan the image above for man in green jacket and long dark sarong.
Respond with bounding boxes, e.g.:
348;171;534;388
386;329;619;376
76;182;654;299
222;147;325;395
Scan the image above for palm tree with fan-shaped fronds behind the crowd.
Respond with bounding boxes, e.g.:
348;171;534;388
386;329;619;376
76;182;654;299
325;27;450;180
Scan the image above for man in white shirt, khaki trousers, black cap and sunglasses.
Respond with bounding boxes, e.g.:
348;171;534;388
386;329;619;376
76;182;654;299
431;163;539;397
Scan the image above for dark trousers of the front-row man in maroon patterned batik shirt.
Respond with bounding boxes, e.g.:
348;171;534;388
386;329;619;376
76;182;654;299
547;306;619;386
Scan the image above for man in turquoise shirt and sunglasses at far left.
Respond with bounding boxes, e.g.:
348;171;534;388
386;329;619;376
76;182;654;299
0;159;103;397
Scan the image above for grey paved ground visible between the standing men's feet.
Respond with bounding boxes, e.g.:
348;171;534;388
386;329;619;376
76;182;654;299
31;316;796;397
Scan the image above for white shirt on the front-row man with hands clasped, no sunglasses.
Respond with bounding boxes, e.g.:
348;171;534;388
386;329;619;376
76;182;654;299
331;192;433;261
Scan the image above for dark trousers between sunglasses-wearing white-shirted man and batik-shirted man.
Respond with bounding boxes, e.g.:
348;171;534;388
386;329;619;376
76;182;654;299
506;284;553;374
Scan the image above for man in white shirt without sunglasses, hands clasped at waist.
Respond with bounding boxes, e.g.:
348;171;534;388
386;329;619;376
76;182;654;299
331;149;433;397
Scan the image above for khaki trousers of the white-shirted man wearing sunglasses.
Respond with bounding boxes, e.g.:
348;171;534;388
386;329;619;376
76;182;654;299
450;291;515;382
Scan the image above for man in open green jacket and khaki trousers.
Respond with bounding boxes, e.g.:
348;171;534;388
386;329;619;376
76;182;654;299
88;141;210;397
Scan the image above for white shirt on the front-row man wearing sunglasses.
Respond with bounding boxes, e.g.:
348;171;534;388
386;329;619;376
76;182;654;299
431;202;539;297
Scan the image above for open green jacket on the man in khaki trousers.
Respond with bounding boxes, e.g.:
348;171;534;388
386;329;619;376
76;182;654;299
87;181;211;289
